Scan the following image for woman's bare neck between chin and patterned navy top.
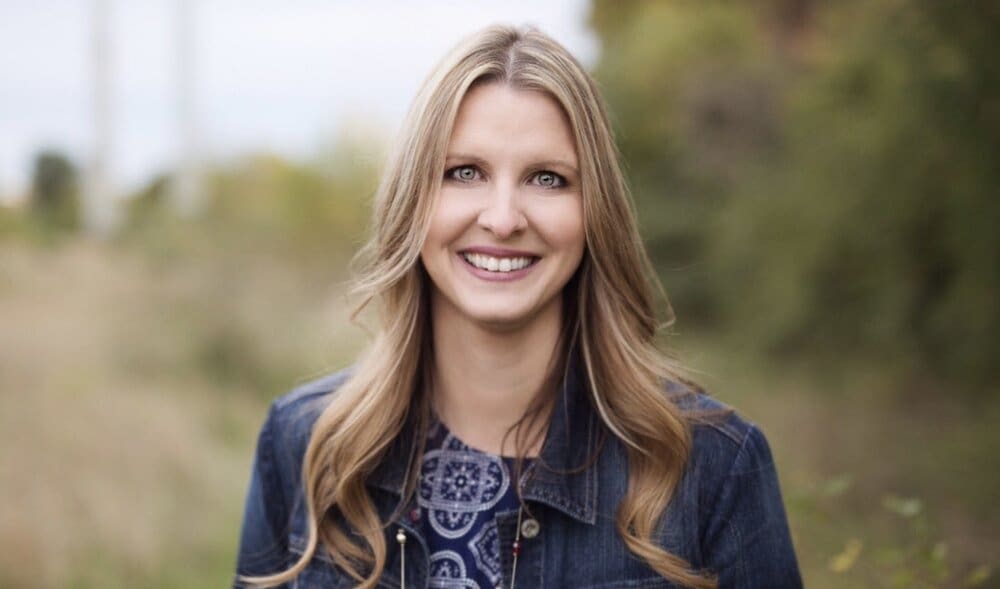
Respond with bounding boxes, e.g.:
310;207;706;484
431;295;562;456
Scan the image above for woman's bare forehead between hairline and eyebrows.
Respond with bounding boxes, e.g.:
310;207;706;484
448;82;576;163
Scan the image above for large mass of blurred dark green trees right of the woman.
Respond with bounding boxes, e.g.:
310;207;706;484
592;0;1000;388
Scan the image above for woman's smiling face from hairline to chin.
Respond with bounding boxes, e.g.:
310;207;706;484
420;83;584;328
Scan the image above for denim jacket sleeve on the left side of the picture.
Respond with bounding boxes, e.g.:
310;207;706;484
233;404;288;587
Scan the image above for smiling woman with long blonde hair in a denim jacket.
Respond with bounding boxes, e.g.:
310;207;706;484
236;27;801;588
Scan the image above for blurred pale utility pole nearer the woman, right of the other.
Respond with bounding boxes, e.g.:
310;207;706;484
170;0;204;217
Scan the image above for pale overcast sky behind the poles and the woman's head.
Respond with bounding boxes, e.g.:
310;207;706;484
0;0;599;199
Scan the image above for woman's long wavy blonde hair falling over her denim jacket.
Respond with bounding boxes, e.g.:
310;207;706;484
238;26;715;588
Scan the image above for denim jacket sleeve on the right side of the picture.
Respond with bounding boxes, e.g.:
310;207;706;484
702;426;802;589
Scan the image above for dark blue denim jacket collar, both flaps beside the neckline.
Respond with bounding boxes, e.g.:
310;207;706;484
368;344;600;524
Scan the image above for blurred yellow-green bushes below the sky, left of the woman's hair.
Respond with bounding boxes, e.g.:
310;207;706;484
120;127;380;272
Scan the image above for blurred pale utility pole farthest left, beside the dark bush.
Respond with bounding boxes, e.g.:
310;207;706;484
83;0;118;237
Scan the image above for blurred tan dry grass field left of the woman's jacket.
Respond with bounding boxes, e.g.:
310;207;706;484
0;242;362;587
